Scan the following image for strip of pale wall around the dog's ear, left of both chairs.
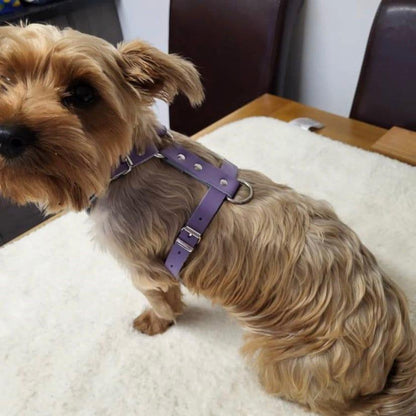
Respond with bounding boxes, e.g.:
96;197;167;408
116;0;170;126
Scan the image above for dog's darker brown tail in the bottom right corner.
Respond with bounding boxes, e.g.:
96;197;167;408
348;328;416;416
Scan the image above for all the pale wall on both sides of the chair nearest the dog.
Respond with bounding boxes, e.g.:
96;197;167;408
117;0;380;125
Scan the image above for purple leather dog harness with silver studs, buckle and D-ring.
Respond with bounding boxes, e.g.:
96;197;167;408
111;127;253;279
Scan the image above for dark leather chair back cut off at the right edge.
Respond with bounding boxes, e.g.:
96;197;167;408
350;0;416;130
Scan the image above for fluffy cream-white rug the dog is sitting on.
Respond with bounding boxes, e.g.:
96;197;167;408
0;118;416;416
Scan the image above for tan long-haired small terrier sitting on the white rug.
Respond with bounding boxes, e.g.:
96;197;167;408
0;24;416;416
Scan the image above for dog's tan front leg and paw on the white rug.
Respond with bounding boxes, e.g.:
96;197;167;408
133;279;184;335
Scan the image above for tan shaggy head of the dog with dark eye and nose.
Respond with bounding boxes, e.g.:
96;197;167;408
0;24;203;213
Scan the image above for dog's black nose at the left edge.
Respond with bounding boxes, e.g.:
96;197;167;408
0;125;36;159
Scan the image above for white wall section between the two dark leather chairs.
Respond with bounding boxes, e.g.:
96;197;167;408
285;0;380;116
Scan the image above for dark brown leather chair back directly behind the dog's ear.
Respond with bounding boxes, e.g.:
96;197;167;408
169;0;303;134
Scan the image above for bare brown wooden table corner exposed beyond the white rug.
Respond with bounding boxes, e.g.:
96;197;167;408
192;94;396;156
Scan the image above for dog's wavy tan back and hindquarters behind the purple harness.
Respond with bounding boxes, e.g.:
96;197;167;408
185;171;416;416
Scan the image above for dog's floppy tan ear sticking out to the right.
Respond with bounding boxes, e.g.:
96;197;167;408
118;40;204;106
